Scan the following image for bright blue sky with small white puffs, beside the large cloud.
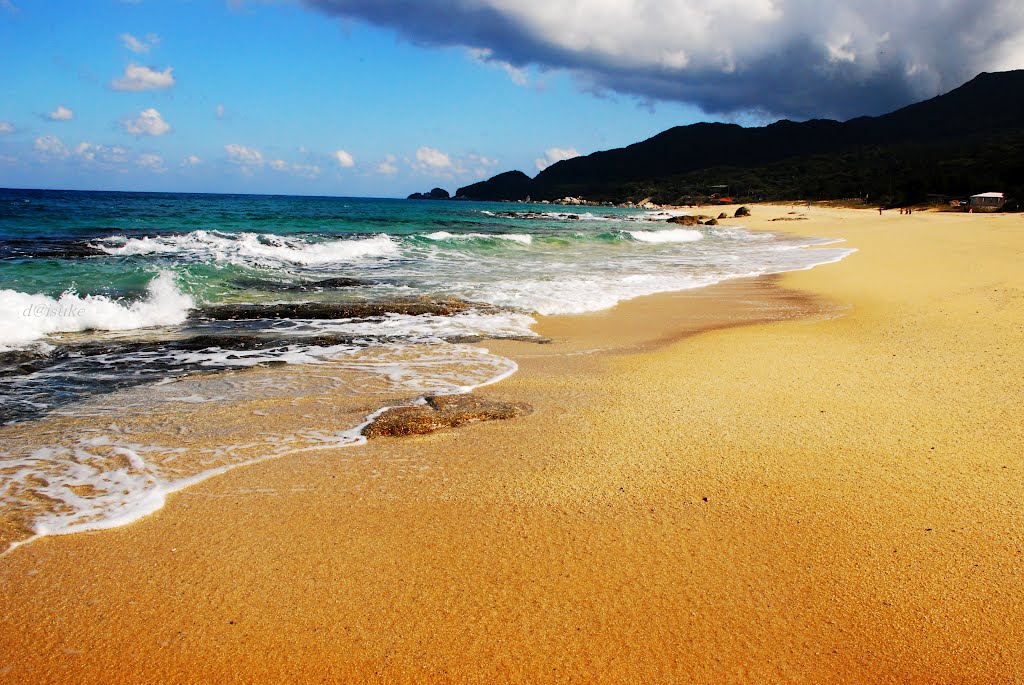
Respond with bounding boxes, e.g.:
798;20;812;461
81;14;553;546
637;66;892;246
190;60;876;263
0;0;698;197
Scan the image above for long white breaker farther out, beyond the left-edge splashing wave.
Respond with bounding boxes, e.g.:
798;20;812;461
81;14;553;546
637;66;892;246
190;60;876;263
93;230;399;266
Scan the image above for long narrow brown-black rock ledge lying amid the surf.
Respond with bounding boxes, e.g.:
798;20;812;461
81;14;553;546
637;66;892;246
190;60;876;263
202;298;489;322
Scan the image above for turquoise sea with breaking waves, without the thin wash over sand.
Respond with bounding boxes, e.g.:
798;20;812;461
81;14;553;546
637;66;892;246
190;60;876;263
0;190;846;422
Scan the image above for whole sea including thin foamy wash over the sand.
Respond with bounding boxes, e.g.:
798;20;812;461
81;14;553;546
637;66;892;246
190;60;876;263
0;189;850;550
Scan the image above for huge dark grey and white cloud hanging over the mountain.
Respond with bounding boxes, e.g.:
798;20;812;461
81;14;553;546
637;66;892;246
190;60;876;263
304;0;1024;119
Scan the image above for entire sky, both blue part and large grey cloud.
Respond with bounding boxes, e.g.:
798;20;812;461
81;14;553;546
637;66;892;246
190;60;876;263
0;0;1024;197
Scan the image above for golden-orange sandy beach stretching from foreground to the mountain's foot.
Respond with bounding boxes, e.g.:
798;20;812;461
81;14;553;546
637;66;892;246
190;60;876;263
0;206;1024;683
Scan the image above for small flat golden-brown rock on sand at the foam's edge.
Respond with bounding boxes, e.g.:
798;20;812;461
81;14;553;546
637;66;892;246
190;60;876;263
362;394;534;437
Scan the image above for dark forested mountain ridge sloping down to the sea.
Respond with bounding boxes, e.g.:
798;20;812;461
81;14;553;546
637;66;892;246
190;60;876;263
456;71;1024;208
